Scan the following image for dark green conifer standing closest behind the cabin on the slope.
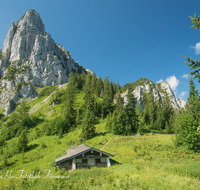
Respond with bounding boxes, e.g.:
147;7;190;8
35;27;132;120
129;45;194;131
81;110;95;140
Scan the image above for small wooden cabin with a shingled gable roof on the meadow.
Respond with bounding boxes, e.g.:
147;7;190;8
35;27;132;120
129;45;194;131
55;144;114;170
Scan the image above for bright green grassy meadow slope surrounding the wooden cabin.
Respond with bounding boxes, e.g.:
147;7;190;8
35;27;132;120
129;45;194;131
0;85;200;189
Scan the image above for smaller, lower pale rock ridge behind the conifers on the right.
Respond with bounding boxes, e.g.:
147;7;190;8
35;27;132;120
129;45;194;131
121;78;186;110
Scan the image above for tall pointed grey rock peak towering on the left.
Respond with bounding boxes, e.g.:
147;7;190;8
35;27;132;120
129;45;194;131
0;10;85;115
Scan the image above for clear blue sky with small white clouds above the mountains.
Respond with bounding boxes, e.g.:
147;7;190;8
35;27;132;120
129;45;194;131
0;0;200;100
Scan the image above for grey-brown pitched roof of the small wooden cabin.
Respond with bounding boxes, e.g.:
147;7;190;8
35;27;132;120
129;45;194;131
55;144;114;163
